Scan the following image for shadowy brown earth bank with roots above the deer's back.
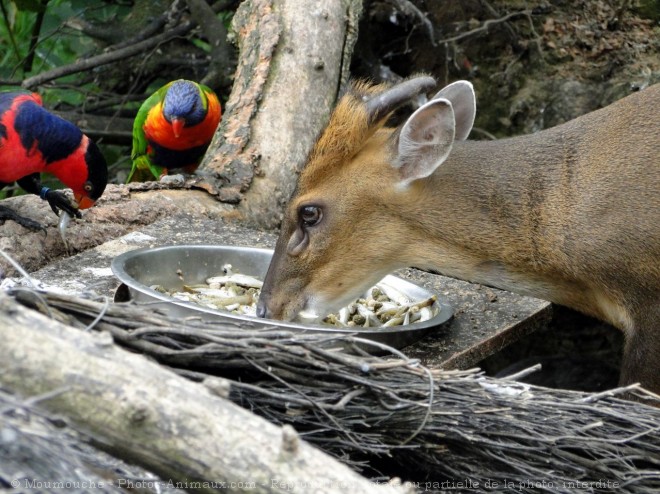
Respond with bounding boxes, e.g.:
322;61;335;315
352;0;660;139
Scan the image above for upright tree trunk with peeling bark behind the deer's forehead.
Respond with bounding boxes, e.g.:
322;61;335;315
199;0;362;228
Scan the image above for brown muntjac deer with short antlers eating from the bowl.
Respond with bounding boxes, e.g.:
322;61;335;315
257;76;660;393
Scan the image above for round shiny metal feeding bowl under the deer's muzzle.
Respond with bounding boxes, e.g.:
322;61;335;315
112;245;453;348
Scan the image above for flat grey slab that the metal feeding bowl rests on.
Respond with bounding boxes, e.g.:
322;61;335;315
24;215;551;369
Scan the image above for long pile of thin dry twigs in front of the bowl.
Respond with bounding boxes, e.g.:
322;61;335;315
10;292;660;493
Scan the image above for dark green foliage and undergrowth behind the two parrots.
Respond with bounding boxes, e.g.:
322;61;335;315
0;0;237;198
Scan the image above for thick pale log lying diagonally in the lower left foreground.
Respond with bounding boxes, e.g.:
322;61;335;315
0;295;403;493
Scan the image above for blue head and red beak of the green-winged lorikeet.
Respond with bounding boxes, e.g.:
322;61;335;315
163;80;208;137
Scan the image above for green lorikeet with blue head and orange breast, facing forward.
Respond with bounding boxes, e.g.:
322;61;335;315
126;79;221;182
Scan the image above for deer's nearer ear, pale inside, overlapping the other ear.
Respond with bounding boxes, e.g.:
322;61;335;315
394;99;455;186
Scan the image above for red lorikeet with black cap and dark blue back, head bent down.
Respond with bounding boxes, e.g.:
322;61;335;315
0;92;108;229
